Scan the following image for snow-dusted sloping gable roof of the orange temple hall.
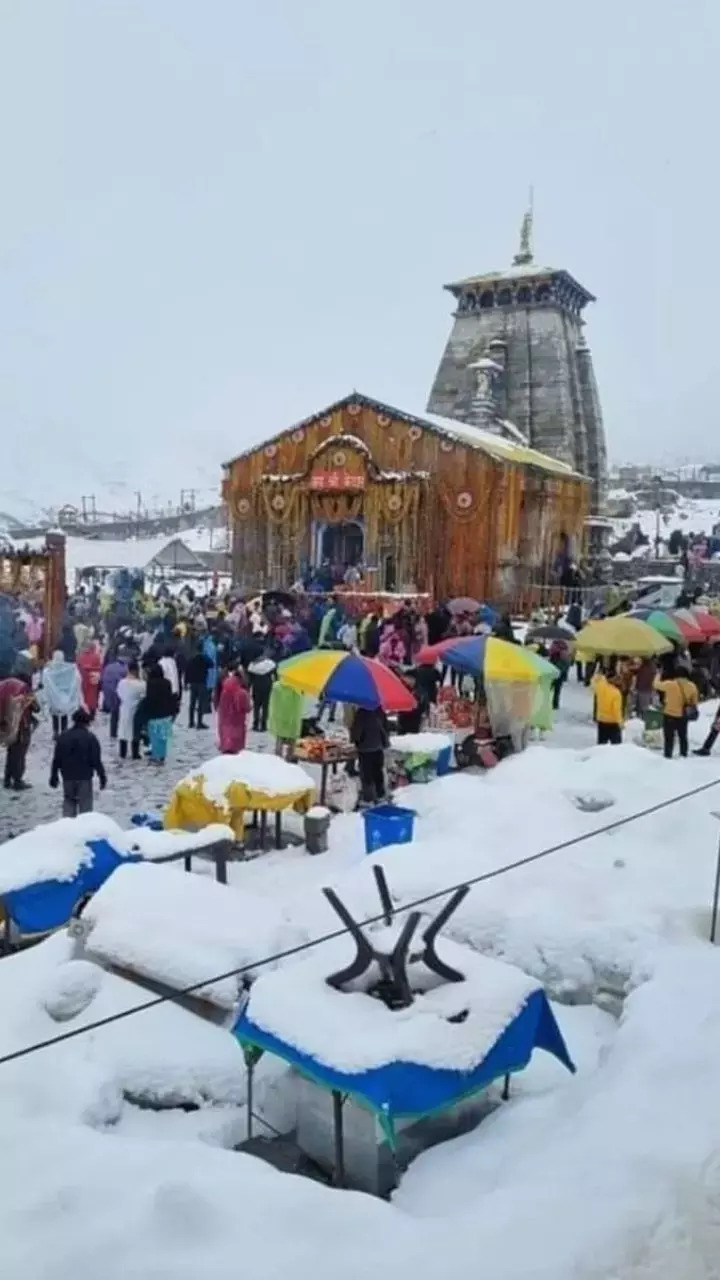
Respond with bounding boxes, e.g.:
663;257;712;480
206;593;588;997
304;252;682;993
224;392;580;476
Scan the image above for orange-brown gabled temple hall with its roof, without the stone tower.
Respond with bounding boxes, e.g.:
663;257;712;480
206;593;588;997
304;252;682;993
223;393;589;600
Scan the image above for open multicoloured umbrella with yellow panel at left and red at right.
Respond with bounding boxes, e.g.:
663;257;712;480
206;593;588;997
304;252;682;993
278;649;415;712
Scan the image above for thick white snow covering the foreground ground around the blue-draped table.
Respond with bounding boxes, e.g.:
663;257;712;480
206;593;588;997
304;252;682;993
0;684;720;1280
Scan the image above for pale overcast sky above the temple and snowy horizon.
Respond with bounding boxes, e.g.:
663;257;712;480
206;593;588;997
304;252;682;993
0;0;720;508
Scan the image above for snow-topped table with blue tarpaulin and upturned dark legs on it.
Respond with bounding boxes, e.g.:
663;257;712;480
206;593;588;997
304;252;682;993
233;924;575;1189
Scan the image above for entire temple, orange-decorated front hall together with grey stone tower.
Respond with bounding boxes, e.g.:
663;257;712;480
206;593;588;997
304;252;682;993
224;216;606;599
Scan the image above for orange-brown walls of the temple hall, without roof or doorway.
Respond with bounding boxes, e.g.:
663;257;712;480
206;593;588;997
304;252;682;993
224;401;588;599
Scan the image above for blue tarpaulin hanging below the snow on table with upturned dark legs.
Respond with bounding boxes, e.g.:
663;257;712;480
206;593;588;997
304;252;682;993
233;991;575;1137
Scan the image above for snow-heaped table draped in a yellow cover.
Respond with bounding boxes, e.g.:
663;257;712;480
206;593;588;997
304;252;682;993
164;751;315;849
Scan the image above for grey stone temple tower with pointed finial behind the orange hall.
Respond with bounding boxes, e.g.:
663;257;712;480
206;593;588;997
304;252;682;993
428;211;607;515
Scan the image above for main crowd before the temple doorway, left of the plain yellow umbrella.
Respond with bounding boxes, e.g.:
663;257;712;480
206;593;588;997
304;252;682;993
0;591;504;815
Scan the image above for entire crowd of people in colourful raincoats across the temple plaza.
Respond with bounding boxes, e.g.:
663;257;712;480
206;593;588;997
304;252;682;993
0;591;720;815
